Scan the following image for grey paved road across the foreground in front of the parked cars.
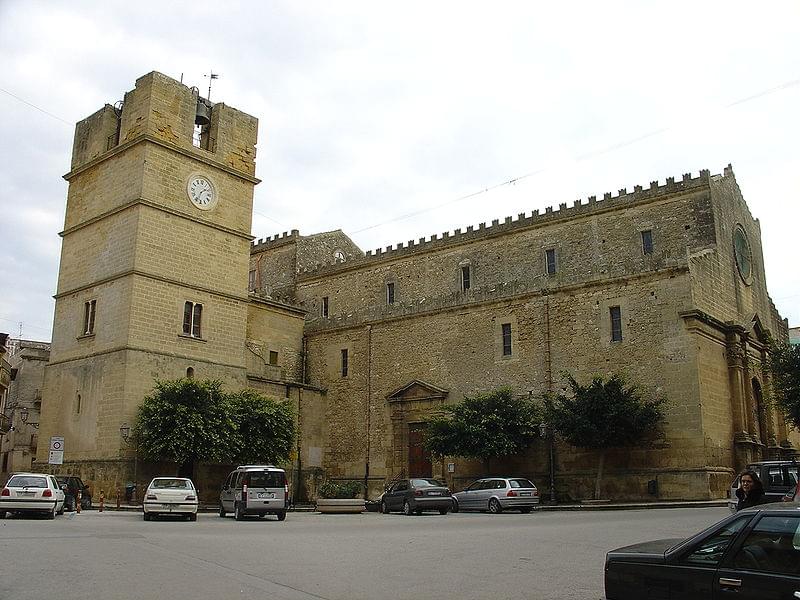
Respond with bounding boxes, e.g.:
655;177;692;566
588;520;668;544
0;508;728;600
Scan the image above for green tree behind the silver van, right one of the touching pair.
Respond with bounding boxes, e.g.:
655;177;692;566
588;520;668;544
230;389;295;464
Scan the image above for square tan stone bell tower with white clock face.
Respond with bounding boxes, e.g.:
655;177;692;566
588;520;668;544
37;72;258;488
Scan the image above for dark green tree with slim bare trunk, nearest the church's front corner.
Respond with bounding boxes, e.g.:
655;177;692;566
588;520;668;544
545;375;665;500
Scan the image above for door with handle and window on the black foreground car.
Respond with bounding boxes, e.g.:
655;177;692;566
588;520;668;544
714;513;800;600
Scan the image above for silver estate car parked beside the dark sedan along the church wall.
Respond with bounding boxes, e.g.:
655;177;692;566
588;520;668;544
453;477;539;514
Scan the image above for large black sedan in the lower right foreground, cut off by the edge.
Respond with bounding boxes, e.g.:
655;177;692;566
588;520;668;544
605;503;800;600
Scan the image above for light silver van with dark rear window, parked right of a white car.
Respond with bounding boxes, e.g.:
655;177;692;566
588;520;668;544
219;465;289;521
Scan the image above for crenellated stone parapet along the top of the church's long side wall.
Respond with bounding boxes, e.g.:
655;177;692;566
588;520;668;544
294;165;720;279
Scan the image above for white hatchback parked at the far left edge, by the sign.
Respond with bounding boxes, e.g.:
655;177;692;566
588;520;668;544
0;473;65;519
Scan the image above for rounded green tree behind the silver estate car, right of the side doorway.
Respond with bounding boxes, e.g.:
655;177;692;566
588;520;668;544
425;387;540;474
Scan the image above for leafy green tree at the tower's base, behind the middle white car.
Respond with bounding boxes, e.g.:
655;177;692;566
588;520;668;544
134;379;237;474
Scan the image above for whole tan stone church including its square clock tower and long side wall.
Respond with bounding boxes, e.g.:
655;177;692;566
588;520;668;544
37;73;800;500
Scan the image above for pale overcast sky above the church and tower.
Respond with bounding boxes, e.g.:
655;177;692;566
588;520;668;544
0;0;800;340
